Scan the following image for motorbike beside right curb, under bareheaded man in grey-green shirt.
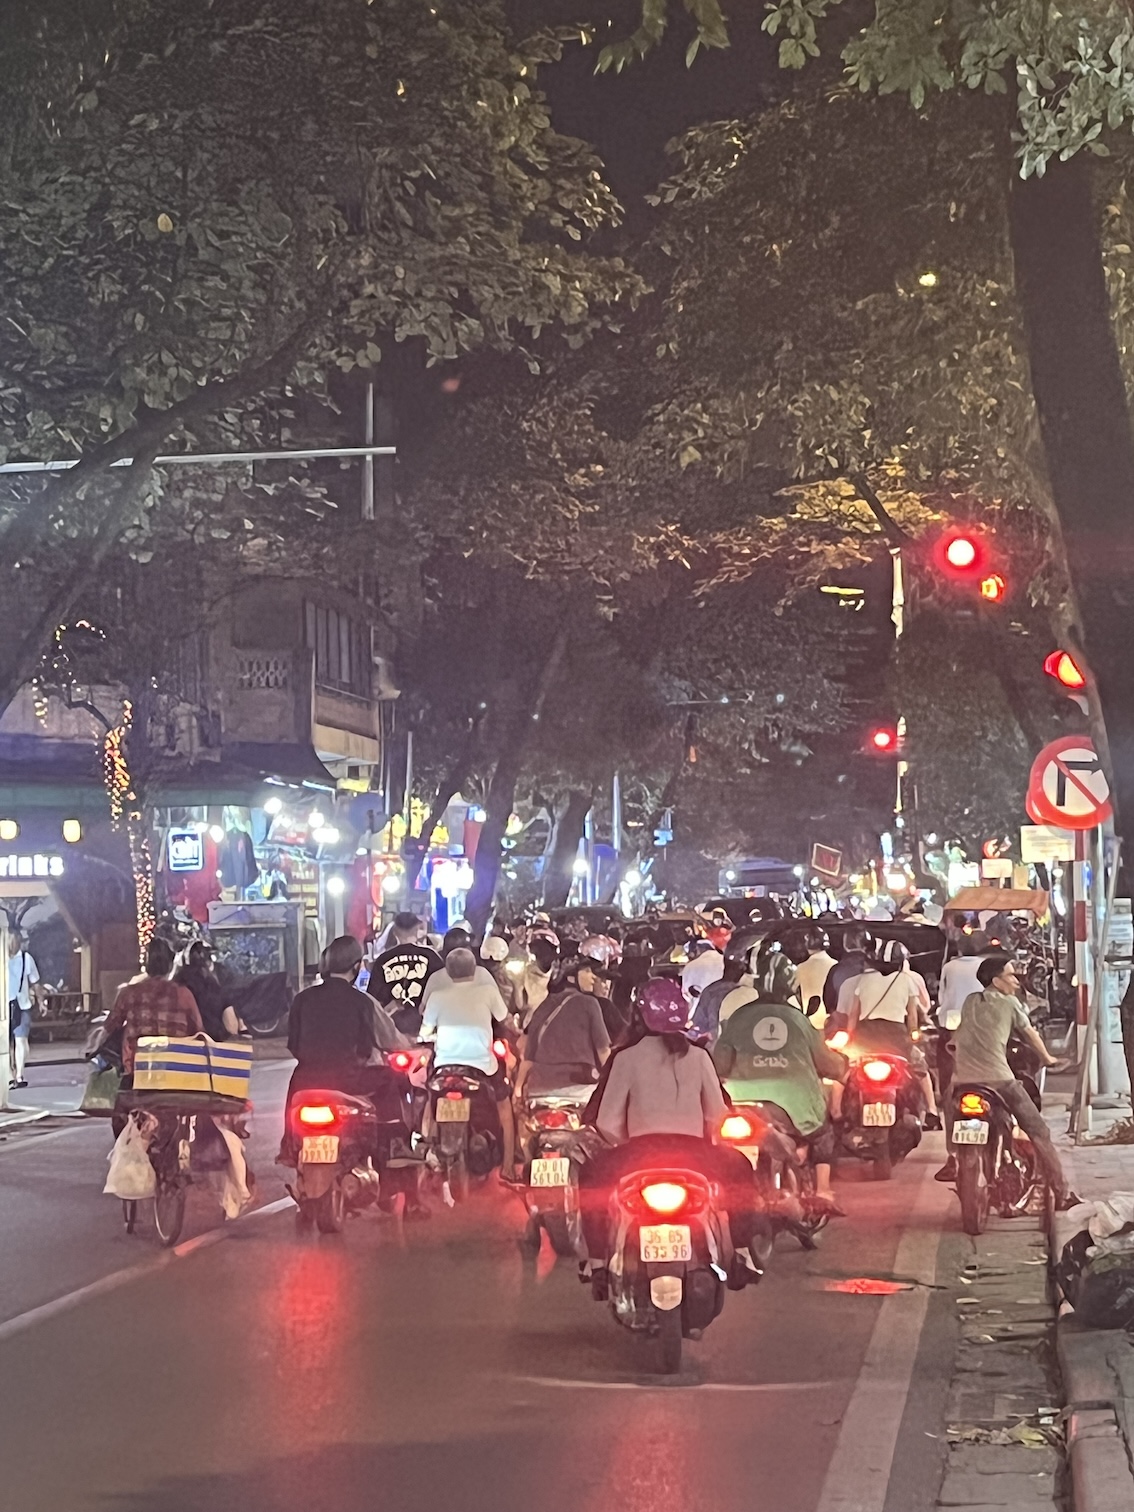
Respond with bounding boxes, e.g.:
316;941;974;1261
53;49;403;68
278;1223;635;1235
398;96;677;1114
951;1037;1045;1234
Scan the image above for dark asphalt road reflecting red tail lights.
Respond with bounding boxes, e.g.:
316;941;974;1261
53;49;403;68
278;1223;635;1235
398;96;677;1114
0;1064;962;1512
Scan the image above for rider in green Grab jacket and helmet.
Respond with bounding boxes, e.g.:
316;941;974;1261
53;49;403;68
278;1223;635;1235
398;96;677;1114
712;953;847;1213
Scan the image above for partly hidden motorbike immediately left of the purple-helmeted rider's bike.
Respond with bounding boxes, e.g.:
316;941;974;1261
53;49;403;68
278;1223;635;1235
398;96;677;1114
520;1086;594;1256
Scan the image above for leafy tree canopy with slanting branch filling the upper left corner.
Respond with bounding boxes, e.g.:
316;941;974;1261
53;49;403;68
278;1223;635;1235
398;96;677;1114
0;0;638;706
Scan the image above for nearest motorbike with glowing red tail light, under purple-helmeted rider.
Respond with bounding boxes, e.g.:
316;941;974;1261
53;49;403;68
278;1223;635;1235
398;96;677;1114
591;1166;733;1374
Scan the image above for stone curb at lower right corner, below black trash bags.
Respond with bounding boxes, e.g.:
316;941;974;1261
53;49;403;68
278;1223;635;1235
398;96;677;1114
1048;1213;1134;1512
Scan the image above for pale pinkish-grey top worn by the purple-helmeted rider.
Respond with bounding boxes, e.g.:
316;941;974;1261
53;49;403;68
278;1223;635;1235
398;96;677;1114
597;1034;726;1145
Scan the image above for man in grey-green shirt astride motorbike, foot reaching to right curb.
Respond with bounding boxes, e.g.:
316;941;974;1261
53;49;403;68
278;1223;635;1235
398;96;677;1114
937;956;1080;1211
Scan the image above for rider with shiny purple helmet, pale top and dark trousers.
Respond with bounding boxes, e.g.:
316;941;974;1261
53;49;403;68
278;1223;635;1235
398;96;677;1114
579;977;762;1288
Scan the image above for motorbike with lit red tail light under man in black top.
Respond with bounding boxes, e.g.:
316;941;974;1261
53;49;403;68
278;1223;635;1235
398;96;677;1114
287;1089;380;1234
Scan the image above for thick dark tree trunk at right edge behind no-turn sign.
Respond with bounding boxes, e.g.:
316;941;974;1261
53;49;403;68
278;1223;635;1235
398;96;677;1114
1009;153;1134;1064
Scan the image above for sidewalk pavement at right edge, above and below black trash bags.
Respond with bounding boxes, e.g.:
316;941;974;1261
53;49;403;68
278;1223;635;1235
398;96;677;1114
1045;1099;1134;1512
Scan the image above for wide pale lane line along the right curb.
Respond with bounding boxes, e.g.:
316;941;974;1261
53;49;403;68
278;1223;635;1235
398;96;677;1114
815;1161;942;1512
